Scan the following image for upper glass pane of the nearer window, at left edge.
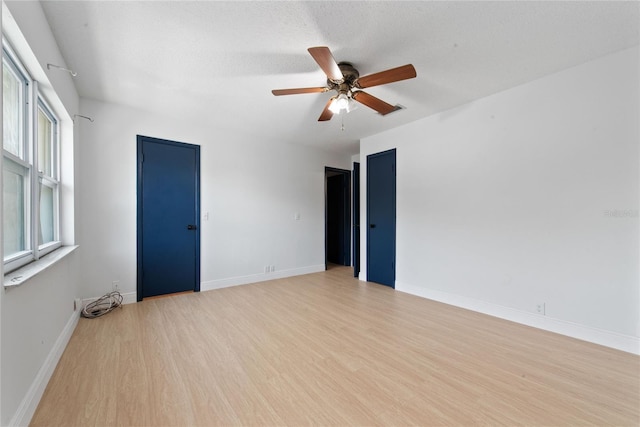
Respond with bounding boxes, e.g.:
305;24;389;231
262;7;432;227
2;61;24;159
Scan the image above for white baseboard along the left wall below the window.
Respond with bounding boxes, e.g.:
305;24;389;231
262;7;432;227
8;308;80;426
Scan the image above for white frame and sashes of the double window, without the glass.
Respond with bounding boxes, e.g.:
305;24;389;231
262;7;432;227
2;37;62;274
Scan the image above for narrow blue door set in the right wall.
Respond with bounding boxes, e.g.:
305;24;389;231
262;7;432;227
367;149;396;288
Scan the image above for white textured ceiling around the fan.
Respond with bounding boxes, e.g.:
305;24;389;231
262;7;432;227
42;1;640;153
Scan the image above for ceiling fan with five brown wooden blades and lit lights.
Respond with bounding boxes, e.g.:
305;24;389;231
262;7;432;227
271;46;416;122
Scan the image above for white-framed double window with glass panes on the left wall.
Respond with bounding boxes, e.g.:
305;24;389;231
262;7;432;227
2;41;60;272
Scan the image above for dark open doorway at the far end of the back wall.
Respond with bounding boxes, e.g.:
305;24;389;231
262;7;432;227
325;167;351;265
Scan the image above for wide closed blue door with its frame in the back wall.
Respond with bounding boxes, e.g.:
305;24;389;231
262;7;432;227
137;136;200;301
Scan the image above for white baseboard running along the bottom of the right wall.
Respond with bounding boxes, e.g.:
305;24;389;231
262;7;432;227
396;281;640;355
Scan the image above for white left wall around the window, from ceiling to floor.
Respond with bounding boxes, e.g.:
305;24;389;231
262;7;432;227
0;2;80;425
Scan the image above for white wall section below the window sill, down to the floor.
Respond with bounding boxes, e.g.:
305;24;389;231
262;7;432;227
1;251;79;426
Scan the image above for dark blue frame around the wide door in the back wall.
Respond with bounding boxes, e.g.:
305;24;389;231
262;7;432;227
136;135;201;302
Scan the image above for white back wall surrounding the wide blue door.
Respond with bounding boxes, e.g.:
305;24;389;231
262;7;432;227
79;99;350;301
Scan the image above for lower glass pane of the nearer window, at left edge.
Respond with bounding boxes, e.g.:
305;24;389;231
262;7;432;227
2;159;26;259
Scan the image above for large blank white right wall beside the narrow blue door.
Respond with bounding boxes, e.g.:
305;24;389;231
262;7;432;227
361;48;640;353
